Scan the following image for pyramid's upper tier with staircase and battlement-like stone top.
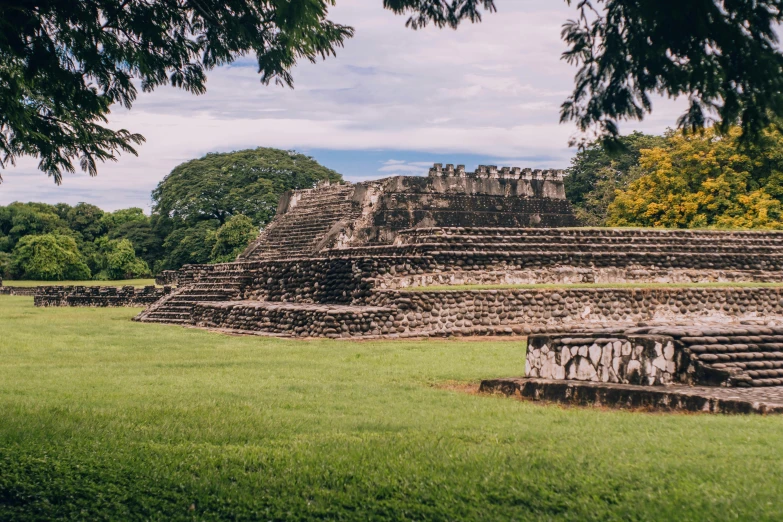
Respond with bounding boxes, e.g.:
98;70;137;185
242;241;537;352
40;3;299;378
239;163;576;260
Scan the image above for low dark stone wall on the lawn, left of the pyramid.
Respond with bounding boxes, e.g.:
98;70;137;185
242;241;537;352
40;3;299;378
34;286;171;307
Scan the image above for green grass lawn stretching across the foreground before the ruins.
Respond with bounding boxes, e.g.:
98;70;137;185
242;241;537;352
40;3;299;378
0;296;783;521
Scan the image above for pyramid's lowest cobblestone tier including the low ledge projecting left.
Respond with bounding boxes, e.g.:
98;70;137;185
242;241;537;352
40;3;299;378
193;287;783;337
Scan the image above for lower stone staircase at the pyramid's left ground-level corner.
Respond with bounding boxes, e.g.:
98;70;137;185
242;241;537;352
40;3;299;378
134;264;252;324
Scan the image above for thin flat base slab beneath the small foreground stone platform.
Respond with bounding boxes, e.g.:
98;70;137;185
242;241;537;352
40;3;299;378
479;377;783;414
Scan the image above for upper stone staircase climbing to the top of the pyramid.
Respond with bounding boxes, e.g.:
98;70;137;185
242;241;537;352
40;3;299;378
241;185;361;261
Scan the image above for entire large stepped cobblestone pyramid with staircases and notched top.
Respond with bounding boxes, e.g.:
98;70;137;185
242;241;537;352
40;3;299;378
138;165;783;350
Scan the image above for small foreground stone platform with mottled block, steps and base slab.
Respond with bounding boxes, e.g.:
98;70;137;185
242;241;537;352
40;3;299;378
482;323;783;413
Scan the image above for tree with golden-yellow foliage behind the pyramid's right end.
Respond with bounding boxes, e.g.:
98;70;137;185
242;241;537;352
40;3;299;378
608;127;783;229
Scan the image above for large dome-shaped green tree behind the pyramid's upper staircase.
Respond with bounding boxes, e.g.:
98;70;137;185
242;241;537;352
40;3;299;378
152;148;342;271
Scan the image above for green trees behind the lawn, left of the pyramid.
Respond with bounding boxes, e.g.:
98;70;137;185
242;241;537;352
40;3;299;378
0;148;342;281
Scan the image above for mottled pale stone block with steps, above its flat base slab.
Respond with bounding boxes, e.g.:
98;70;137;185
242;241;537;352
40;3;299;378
525;325;783;387
